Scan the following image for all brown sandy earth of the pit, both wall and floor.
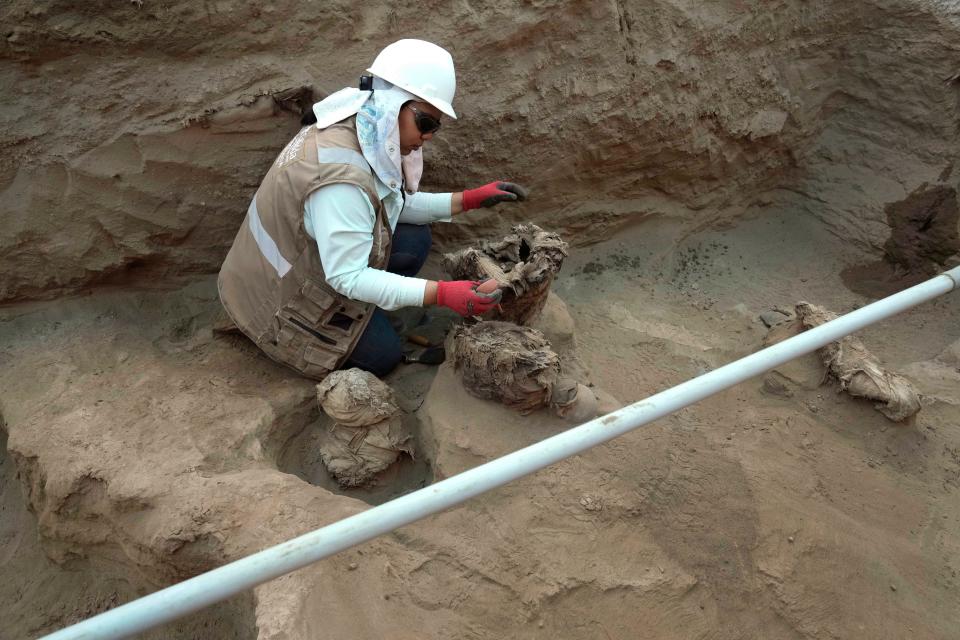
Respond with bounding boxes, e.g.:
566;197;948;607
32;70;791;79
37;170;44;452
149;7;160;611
0;0;960;640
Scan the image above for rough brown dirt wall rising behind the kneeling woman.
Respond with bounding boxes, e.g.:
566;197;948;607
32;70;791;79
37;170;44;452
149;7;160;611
0;0;960;302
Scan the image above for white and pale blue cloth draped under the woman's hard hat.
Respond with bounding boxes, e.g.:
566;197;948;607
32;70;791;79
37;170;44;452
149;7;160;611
313;77;423;193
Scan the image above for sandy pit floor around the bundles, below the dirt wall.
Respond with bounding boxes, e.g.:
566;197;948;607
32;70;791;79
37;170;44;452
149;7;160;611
0;202;960;638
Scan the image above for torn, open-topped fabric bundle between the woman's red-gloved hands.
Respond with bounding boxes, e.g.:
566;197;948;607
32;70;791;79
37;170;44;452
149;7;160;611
443;224;567;325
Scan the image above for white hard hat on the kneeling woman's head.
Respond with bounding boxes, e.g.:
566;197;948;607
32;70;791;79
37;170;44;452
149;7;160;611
367;40;457;119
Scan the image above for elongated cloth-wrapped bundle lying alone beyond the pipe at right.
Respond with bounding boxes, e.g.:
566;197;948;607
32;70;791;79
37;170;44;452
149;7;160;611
796;302;920;422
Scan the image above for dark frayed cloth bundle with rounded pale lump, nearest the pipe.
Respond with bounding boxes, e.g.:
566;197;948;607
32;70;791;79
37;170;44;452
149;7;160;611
453;320;596;419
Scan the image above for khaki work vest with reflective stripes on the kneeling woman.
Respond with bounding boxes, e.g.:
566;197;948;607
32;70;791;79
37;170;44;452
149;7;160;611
217;118;392;380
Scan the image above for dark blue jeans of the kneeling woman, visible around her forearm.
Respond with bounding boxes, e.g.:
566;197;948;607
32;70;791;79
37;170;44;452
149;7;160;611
343;223;433;378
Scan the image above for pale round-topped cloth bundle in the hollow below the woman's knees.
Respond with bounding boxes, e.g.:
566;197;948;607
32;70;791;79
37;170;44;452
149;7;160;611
317;369;413;486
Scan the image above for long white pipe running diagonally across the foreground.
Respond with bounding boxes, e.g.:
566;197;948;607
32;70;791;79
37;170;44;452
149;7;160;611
44;267;960;640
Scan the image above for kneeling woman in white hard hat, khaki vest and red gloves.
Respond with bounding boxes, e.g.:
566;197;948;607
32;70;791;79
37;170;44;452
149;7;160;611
218;40;526;379
